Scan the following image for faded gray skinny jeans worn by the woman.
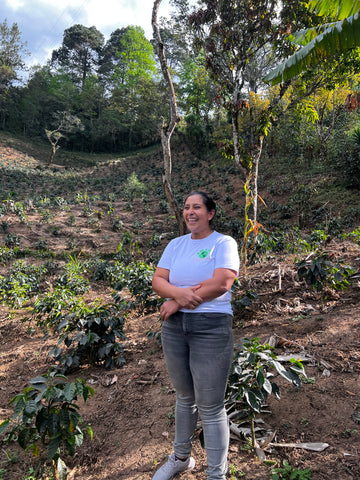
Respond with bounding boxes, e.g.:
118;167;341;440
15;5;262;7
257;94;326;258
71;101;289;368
161;312;233;480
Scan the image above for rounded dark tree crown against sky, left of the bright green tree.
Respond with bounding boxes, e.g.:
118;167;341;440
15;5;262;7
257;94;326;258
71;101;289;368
51;24;105;90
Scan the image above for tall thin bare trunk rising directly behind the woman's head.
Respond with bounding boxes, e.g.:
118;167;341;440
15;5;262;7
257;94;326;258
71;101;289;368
151;0;185;235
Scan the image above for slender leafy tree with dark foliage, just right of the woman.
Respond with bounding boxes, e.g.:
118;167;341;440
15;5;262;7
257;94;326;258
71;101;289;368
189;0;296;264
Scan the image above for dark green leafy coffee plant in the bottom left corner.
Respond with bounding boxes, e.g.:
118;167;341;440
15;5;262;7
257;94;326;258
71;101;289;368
0;369;94;480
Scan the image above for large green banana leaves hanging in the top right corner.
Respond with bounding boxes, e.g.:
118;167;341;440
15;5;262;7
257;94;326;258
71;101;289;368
264;0;360;85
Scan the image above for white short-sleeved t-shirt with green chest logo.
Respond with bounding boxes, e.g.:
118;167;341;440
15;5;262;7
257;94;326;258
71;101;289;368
158;231;240;315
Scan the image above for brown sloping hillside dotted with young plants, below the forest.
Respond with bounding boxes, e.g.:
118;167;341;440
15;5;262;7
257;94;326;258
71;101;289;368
0;136;360;480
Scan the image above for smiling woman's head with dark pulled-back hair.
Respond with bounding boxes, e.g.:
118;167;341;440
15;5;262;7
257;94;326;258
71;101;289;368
183;194;215;239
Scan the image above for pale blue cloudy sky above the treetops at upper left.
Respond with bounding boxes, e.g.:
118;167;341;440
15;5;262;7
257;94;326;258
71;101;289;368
0;0;174;66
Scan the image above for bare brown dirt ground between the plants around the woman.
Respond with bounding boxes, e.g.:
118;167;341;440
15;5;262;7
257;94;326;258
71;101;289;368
0;137;360;480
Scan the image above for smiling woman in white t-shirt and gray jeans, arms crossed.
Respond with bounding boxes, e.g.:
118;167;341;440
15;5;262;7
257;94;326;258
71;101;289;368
152;192;239;480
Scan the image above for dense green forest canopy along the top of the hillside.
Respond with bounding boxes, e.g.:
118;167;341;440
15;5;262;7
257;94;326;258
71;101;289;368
0;0;360;191
